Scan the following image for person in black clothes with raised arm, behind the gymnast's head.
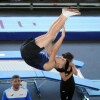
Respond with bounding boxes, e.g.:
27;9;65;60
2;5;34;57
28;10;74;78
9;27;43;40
60;52;78;100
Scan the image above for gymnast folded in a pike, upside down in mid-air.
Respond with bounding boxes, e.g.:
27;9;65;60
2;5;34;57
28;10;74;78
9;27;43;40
20;8;80;72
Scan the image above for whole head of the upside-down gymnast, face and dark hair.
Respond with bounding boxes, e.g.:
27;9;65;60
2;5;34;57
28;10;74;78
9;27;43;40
56;57;69;72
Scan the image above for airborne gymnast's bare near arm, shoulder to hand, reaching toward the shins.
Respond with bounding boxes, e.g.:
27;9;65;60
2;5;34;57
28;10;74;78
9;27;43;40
44;27;65;70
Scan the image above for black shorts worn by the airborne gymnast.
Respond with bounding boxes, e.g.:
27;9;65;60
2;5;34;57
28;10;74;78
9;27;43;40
20;38;44;68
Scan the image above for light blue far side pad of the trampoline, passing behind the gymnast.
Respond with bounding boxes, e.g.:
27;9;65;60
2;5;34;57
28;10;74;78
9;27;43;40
0;51;84;68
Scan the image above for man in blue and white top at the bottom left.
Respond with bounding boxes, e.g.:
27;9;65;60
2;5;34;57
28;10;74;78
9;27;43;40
2;75;31;100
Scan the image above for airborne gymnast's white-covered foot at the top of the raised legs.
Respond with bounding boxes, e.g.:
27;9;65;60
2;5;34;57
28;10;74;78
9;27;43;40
62;8;81;17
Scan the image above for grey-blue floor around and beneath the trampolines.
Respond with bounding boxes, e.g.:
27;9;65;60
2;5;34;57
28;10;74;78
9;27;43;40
0;41;100;100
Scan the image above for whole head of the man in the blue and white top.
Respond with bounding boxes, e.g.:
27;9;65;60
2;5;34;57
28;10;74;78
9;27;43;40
11;75;21;91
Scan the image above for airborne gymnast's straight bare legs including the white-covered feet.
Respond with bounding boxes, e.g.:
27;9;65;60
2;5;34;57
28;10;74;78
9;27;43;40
35;8;80;48
